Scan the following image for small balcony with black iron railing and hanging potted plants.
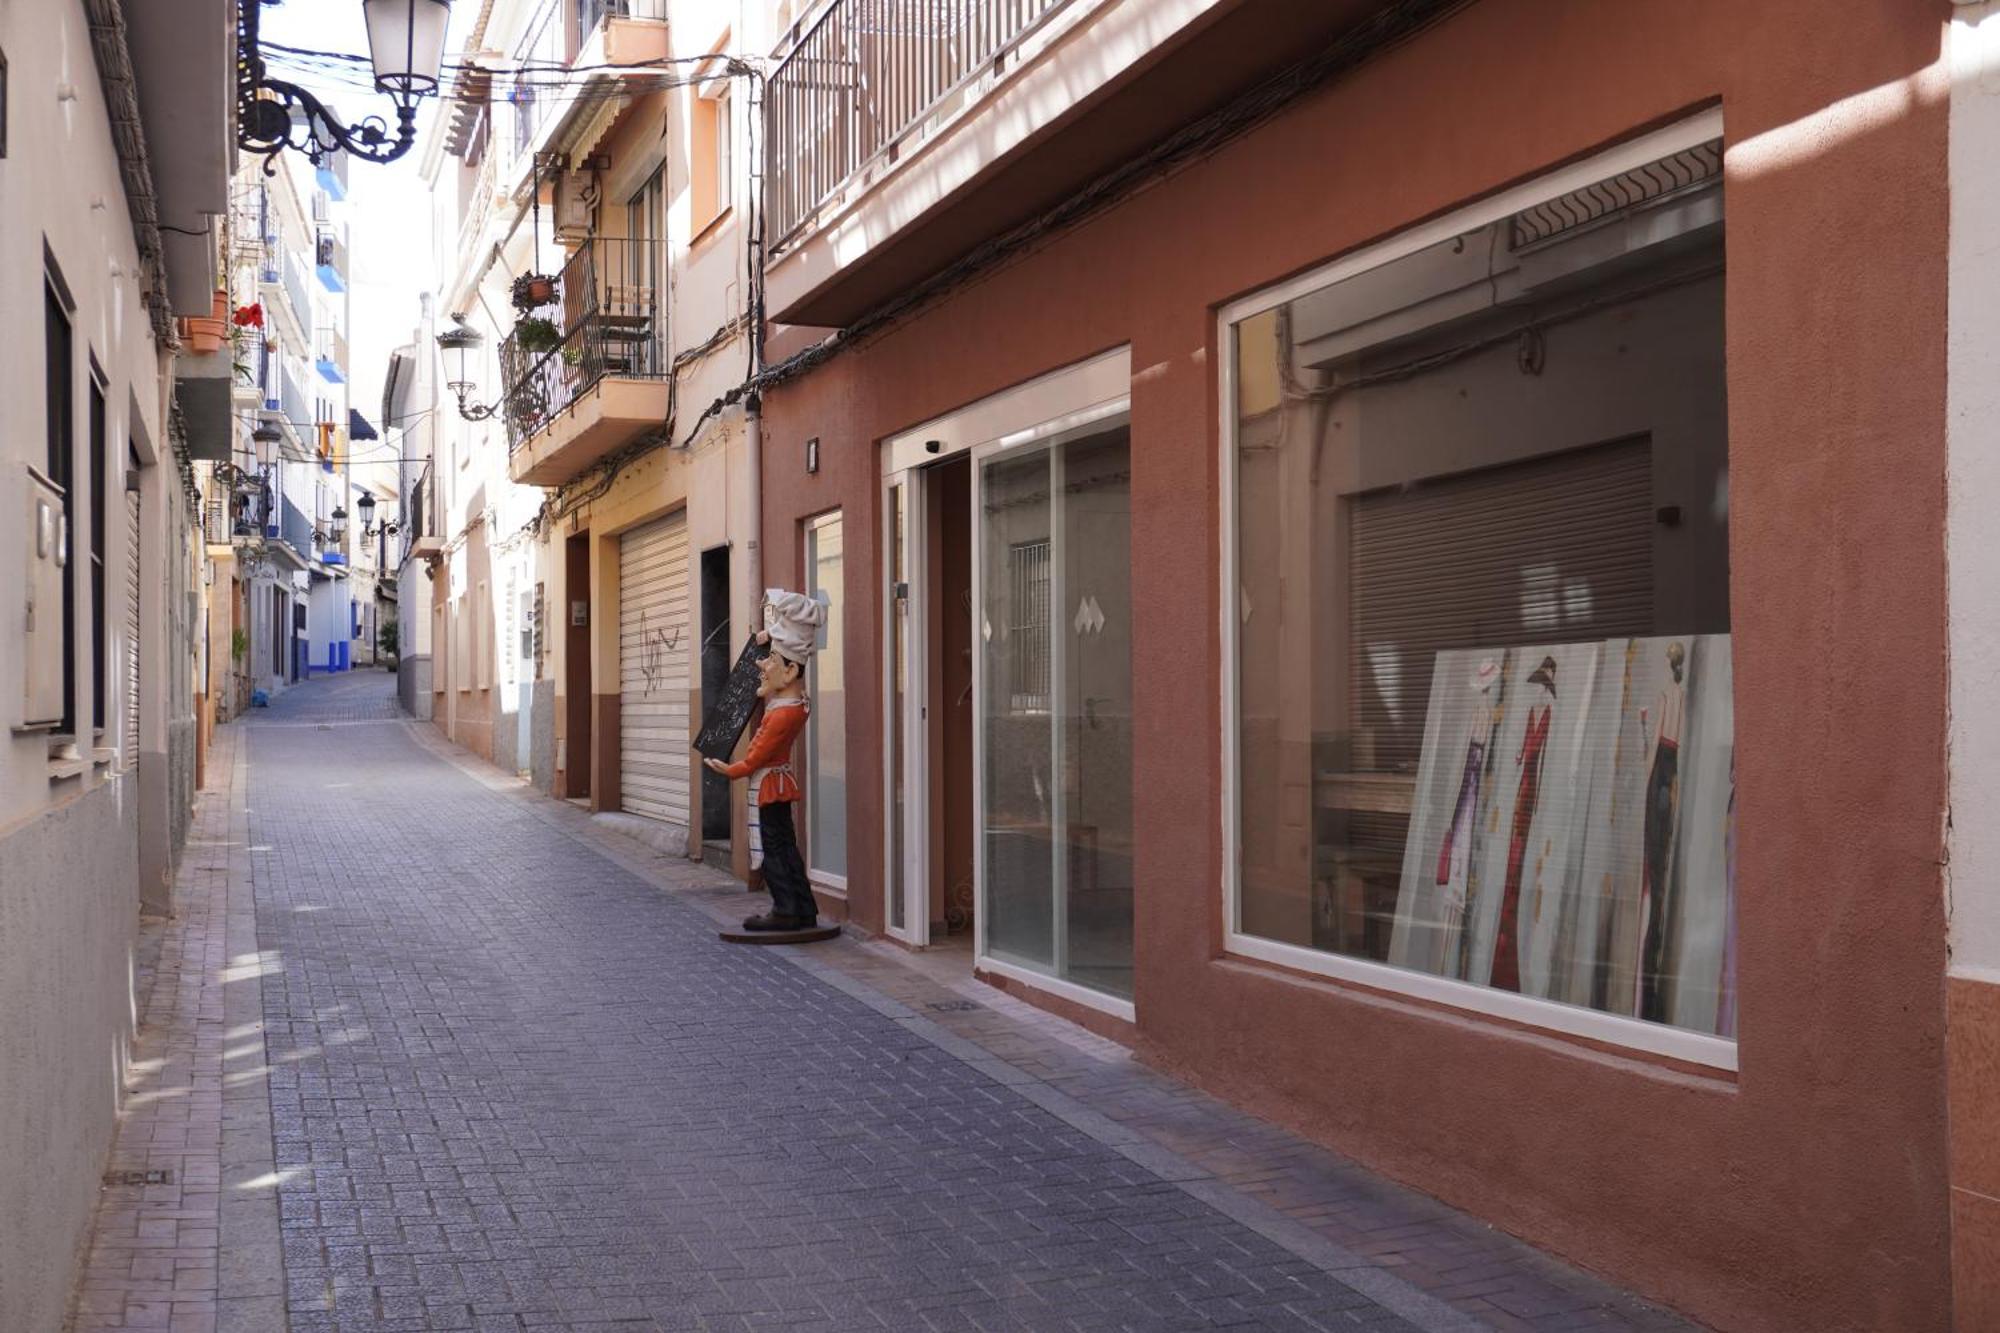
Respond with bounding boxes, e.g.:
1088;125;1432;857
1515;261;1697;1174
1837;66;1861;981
500;236;668;486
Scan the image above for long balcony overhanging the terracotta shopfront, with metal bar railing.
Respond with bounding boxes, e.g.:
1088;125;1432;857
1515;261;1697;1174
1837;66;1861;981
764;0;1394;328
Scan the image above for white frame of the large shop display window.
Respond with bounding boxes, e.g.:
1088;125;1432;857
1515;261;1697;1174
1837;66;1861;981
1216;108;1738;1071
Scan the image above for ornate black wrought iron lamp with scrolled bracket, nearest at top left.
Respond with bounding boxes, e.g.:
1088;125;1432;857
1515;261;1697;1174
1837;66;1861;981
236;0;452;174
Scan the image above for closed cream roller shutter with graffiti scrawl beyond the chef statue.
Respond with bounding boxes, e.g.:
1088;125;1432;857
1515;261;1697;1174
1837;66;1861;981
618;514;694;827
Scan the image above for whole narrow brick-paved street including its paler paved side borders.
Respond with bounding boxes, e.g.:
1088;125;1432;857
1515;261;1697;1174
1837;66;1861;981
76;673;1684;1333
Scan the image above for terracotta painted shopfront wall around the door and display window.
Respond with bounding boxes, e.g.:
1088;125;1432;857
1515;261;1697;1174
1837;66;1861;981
764;0;1950;1333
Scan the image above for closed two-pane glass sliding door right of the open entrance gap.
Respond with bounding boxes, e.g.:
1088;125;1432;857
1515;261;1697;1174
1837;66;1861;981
976;422;1134;999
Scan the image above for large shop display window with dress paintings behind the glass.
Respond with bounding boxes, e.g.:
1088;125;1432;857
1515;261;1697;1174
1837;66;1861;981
1226;134;1736;1063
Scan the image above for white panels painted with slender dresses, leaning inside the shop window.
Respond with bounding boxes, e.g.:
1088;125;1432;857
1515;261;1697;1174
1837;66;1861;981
1390;634;1734;1033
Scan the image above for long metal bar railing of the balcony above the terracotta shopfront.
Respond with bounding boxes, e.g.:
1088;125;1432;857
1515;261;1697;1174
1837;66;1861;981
764;0;1070;248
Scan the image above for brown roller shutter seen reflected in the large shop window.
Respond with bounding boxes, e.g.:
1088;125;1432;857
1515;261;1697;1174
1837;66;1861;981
1348;438;1654;773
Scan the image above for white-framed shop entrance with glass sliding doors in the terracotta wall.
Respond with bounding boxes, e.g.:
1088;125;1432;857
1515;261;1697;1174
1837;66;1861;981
882;348;1138;1019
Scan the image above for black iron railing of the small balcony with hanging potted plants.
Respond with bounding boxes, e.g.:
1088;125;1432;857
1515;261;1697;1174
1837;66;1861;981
500;236;668;450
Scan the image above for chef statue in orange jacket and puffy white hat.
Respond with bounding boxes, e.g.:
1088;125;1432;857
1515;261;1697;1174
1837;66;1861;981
702;588;826;931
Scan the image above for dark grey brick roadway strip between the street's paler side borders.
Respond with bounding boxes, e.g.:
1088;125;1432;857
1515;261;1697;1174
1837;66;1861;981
227;683;1412;1333
